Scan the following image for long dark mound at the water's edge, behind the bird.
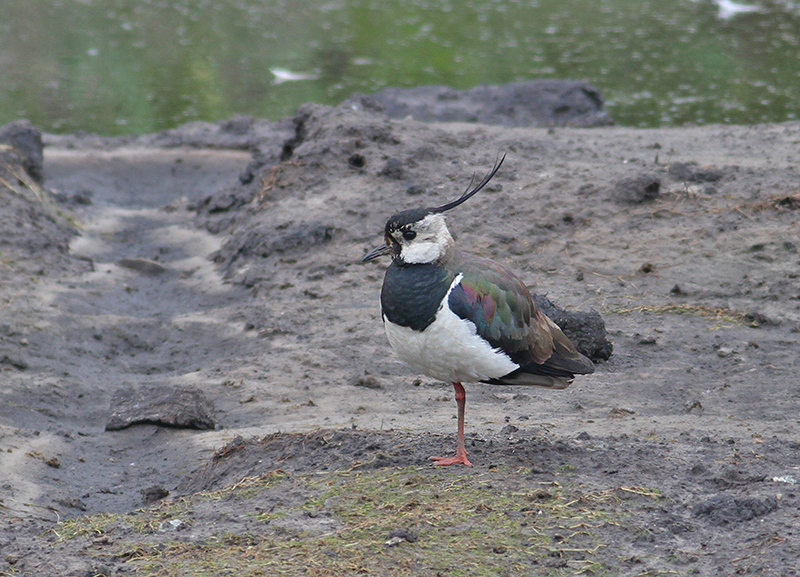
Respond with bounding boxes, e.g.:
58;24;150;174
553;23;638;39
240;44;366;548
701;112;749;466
345;79;614;126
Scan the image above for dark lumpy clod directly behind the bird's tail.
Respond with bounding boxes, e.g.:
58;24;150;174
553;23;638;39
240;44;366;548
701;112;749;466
533;295;614;361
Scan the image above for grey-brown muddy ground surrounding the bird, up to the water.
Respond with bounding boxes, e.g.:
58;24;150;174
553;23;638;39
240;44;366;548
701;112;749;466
0;105;800;575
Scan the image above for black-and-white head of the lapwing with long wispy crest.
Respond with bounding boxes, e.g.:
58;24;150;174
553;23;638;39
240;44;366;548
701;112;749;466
362;155;506;264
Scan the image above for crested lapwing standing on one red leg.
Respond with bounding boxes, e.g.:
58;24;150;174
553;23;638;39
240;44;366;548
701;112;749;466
362;154;594;466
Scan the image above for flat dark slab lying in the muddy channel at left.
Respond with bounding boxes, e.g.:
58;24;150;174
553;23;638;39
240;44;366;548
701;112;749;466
106;385;216;431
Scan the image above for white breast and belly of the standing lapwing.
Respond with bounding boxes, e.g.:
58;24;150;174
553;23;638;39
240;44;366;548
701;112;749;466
383;275;519;383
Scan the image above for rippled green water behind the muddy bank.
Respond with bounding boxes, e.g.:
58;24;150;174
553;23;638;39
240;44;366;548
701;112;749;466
0;0;800;135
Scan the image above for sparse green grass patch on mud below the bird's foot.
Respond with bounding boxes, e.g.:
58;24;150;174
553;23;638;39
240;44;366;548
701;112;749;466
48;467;660;577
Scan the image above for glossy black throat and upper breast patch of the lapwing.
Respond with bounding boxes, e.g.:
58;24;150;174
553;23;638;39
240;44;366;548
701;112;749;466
381;261;455;332
